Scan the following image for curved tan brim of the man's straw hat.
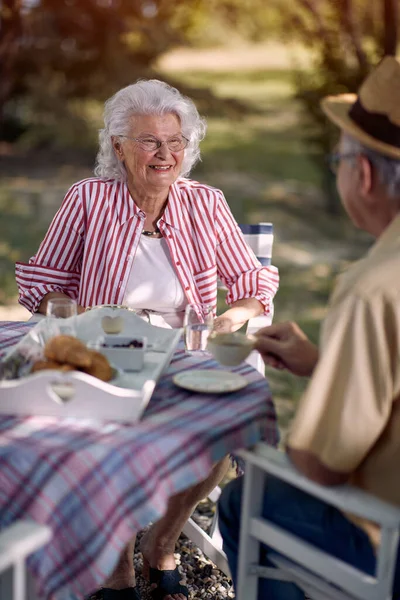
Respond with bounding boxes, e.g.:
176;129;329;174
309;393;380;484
321;94;400;159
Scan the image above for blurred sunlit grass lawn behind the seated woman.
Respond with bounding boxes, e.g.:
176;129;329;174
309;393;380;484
0;58;370;427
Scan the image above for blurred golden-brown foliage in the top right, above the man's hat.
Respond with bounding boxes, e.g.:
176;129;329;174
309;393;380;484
274;0;399;213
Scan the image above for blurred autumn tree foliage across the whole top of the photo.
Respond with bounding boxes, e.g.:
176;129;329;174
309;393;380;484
0;0;399;212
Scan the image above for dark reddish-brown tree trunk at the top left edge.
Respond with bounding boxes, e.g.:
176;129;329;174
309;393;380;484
0;0;22;122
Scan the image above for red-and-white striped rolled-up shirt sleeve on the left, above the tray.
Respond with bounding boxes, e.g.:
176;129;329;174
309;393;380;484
16;186;84;312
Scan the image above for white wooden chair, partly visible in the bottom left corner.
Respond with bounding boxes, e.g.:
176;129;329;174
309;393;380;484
0;521;52;600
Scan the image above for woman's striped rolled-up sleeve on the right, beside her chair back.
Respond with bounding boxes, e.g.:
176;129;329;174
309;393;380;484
216;193;279;315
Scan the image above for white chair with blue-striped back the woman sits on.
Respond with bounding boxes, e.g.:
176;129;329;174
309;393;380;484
183;223;274;577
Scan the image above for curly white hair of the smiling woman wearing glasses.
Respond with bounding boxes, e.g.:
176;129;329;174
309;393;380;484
94;79;207;181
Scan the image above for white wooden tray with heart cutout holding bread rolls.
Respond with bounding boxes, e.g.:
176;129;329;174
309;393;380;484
0;308;182;422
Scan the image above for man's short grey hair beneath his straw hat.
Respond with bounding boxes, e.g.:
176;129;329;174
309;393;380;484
341;134;400;208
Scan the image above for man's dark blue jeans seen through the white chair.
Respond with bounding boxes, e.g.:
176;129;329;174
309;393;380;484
218;476;400;600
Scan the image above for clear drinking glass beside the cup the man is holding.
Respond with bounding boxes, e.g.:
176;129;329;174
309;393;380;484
183;304;214;352
